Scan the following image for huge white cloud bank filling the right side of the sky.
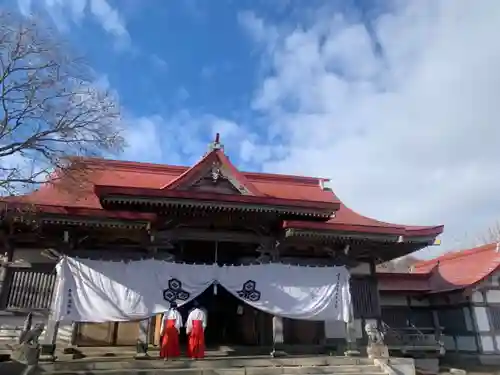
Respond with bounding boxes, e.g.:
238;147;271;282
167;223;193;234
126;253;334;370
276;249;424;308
239;0;500;258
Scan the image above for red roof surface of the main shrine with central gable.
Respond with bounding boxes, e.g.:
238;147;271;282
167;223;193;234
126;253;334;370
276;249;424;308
5;145;443;236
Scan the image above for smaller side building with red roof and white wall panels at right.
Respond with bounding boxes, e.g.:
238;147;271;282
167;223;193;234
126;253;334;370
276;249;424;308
377;243;500;363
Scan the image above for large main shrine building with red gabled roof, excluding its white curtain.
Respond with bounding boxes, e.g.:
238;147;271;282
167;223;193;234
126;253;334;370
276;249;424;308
0;136;443;356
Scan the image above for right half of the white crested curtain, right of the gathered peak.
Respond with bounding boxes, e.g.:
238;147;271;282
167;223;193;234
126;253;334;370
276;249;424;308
218;263;350;321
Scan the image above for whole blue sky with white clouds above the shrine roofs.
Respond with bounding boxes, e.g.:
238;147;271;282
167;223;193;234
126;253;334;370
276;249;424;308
1;0;500;256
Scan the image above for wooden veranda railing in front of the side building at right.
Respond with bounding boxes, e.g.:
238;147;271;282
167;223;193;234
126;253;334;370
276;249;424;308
382;323;445;356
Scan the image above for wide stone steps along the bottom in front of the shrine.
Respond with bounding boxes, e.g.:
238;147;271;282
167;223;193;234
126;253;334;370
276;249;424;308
0;356;386;375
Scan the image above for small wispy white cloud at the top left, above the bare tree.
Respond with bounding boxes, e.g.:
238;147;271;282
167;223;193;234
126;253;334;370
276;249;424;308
17;0;130;47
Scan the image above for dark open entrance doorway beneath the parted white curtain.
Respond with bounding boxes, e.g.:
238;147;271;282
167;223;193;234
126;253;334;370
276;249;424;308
179;285;270;347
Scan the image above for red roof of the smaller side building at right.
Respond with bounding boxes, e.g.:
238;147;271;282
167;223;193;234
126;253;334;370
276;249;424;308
413;243;500;292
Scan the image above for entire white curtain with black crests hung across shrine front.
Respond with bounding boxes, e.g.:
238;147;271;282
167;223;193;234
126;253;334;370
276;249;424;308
52;257;351;322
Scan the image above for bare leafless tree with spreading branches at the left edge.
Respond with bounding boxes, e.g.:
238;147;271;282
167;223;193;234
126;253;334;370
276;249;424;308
0;12;124;195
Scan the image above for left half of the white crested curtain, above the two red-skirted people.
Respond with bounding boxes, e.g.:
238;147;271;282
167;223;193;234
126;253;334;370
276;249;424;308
53;257;215;322
